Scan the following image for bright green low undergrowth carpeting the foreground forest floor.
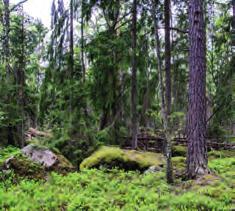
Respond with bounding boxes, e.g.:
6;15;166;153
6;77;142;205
0;148;235;211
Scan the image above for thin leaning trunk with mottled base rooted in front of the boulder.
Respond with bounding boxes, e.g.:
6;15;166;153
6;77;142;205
152;0;173;183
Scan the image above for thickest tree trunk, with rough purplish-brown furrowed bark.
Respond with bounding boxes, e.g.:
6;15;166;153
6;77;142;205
186;0;207;178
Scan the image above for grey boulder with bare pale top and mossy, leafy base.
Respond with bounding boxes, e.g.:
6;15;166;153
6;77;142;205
0;145;75;179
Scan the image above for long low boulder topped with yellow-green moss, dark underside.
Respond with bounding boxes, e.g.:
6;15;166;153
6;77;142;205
80;147;164;172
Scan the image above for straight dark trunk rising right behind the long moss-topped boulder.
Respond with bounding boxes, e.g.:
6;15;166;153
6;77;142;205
131;0;138;149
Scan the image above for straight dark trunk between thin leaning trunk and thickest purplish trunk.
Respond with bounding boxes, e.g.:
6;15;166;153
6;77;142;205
164;0;171;115
